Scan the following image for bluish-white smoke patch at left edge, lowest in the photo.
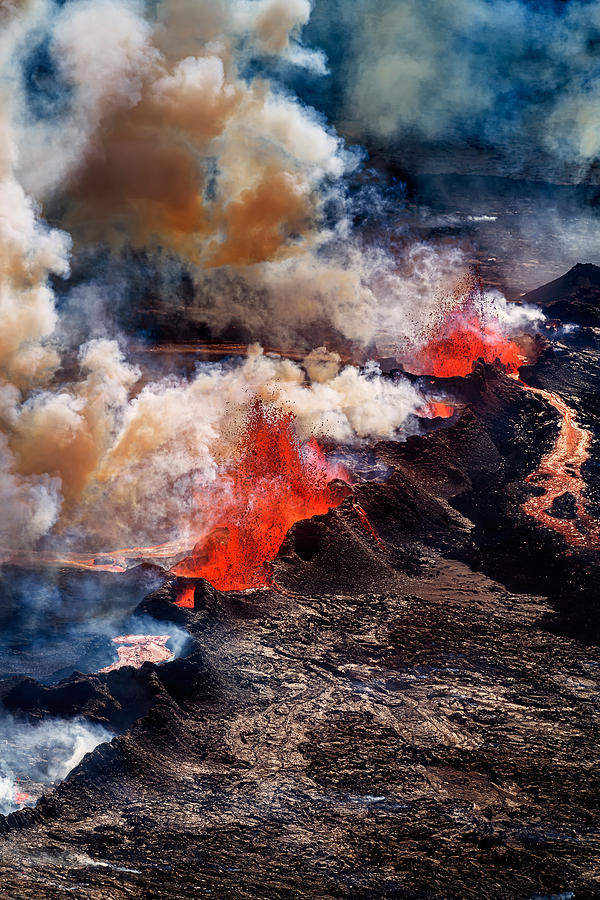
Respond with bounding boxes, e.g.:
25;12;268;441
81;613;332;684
0;712;113;815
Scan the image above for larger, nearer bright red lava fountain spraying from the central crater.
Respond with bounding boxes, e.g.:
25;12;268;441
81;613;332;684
172;401;345;590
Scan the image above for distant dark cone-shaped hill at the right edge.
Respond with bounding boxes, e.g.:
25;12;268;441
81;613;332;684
522;263;600;326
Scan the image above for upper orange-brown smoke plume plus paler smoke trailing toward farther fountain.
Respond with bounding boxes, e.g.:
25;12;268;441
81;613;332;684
6;0;476;349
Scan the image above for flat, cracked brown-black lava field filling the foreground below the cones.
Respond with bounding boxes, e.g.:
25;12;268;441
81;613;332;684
0;559;600;900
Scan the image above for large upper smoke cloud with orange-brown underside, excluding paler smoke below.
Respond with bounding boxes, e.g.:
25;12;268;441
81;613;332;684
15;0;349;266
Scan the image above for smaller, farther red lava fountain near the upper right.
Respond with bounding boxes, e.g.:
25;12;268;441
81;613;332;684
403;277;523;378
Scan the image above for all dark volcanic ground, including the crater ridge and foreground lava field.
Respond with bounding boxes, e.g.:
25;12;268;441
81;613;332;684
0;276;600;900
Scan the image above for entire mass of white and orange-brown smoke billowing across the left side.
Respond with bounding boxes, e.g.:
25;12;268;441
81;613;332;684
0;0;548;564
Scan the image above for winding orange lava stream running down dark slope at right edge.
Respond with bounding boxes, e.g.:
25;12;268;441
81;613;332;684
519;379;600;548
